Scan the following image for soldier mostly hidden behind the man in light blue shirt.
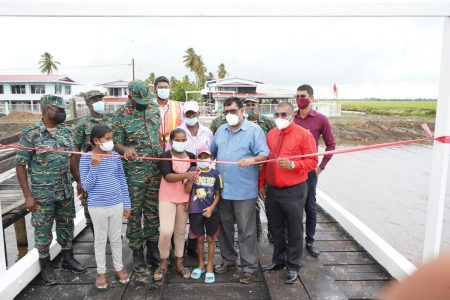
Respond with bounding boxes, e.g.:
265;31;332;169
209;97;275;241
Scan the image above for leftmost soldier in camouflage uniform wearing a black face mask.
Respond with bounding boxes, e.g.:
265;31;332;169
16;95;86;285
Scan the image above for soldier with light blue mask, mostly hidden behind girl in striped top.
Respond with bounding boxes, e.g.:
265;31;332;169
73;90;112;232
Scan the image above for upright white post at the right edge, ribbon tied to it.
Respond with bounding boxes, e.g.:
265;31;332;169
423;17;450;262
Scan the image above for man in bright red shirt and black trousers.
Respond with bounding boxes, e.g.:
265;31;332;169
259;103;318;284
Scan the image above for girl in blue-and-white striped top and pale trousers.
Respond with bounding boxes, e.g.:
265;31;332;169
80;125;131;290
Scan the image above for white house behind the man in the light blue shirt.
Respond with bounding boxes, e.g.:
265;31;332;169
202;77;293;113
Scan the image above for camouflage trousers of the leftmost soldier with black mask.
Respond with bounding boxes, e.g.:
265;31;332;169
31;191;75;258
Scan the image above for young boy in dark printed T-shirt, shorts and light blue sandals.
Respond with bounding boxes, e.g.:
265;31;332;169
185;146;223;283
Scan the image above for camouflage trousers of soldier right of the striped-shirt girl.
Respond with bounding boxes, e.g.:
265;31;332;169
125;166;161;250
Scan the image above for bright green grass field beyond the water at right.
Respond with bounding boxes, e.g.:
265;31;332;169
340;100;436;117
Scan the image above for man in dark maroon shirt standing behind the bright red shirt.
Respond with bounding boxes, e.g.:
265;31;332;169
294;84;336;257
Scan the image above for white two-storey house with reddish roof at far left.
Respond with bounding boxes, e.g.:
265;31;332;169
0;75;77;113
